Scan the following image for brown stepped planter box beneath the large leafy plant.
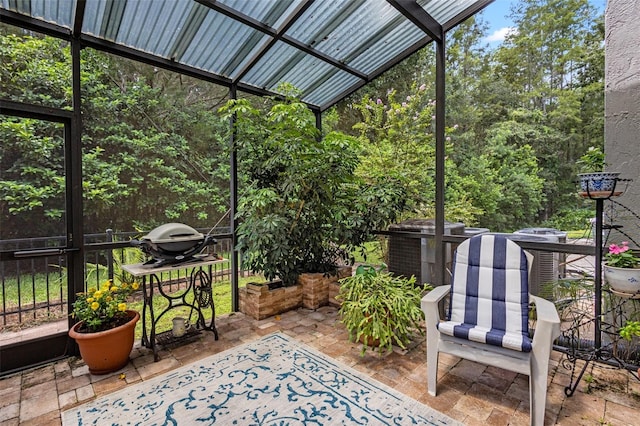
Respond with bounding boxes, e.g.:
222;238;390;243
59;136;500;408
239;266;351;320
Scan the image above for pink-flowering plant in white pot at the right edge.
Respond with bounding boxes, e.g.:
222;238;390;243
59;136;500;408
604;241;640;295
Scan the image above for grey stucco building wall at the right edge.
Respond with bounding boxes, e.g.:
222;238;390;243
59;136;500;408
604;0;640;243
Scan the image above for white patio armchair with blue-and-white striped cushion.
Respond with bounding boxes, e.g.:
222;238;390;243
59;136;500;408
422;234;560;425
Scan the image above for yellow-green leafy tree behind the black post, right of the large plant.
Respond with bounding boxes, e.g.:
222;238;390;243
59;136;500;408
351;84;480;223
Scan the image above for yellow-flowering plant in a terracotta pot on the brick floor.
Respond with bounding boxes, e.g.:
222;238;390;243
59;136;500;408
69;280;140;374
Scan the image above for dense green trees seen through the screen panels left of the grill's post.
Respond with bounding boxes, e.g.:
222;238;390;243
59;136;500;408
0;34;229;238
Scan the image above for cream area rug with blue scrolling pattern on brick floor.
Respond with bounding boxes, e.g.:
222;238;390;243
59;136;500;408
62;333;461;426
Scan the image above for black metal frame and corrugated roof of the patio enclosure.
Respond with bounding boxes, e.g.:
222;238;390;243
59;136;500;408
0;0;491;373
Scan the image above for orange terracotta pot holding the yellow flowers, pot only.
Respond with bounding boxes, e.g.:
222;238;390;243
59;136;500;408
69;311;140;374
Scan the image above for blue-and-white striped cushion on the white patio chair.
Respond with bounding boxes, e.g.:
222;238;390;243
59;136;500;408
438;235;531;352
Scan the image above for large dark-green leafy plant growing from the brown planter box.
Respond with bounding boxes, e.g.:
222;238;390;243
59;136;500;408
221;86;405;312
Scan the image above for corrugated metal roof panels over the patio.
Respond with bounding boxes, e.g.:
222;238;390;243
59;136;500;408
0;0;491;110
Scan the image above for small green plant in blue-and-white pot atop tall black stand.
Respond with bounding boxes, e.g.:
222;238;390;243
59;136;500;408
578;146;620;198
